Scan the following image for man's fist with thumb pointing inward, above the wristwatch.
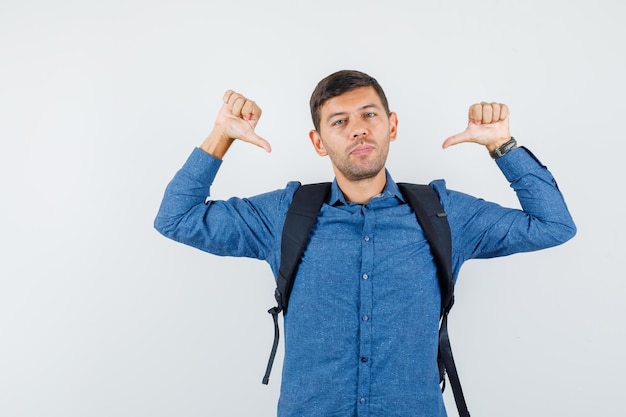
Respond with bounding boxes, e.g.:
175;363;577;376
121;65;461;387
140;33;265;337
442;101;511;152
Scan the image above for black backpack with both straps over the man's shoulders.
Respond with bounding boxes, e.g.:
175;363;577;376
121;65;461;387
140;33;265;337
263;182;470;417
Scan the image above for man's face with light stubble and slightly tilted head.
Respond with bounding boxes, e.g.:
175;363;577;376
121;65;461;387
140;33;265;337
309;87;398;181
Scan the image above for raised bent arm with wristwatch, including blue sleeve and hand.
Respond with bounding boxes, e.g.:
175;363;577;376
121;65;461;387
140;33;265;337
434;102;576;267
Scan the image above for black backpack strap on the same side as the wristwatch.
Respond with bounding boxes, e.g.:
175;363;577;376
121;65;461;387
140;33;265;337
398;183;469;417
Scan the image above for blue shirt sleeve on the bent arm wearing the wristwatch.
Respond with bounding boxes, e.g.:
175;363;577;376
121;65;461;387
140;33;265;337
431;147;576;267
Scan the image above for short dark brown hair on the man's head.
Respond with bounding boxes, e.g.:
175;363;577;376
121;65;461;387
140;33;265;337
309;70;390;131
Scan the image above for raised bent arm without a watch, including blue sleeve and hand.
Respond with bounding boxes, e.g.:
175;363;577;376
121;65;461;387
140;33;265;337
154;90;295;259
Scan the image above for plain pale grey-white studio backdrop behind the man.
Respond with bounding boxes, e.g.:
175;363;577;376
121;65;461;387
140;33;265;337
0;0;626;417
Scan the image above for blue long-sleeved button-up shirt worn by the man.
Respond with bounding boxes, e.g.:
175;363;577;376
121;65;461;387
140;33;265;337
155;148;576;417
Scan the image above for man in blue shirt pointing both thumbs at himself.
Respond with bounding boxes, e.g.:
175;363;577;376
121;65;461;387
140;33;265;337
155;71;576;417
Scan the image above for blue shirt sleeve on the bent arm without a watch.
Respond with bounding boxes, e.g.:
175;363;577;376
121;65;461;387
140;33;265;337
154;148;299;266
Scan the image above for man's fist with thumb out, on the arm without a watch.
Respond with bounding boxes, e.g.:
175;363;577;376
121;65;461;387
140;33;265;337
200;90;272;158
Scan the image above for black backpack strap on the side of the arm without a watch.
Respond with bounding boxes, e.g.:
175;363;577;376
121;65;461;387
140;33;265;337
263;182;331;385
